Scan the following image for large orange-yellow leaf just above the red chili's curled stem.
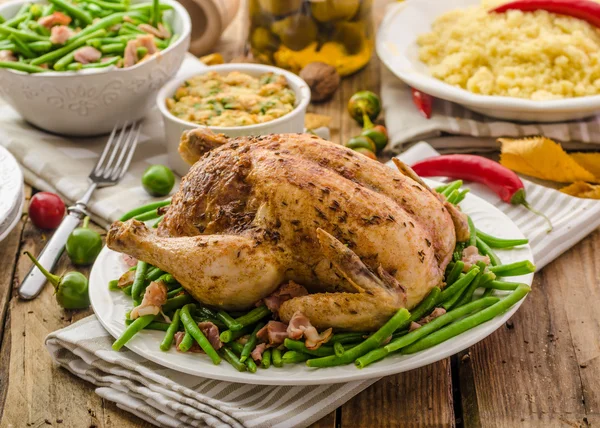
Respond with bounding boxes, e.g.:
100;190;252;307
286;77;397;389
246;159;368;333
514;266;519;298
498;137;595;183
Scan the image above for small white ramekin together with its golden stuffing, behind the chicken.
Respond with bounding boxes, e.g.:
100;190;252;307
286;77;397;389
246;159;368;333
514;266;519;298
156;64;310;175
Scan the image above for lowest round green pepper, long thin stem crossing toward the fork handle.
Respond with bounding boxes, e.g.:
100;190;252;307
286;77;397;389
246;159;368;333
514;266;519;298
25;251;90;309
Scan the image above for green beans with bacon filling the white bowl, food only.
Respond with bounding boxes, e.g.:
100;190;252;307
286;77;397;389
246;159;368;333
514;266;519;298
0;0;178;73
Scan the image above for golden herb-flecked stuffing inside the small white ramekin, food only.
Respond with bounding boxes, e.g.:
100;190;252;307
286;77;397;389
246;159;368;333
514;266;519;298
167;71;296;127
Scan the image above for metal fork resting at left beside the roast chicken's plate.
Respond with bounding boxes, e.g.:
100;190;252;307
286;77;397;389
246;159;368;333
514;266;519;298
19;122;141;300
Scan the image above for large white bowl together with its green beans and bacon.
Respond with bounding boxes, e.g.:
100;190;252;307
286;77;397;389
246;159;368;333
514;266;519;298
0;0;191;136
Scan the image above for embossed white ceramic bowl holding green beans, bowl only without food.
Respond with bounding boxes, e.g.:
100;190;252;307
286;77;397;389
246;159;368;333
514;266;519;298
0;0;191;136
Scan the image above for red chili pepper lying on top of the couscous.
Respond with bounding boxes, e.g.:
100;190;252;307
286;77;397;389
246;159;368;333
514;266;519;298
490;0;600;27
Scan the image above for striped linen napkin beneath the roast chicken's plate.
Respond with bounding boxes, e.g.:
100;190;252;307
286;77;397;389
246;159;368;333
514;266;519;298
46;143;600;428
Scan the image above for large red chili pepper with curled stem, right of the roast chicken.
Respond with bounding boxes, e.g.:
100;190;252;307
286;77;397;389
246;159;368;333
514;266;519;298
412;155;552;231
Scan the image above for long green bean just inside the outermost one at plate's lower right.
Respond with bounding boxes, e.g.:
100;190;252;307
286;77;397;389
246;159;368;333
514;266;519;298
355;297;500;369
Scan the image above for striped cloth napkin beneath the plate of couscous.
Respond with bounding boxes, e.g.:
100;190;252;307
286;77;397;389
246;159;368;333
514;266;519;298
381;65;600;153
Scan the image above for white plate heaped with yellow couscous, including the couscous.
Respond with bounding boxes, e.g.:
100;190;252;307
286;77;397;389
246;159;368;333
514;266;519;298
377;0;600;122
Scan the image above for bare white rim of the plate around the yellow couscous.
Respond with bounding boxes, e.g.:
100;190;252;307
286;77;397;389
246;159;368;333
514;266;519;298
376;0;600;122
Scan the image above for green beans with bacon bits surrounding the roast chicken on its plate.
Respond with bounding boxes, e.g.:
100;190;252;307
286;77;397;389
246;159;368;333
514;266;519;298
109;180;535;373
